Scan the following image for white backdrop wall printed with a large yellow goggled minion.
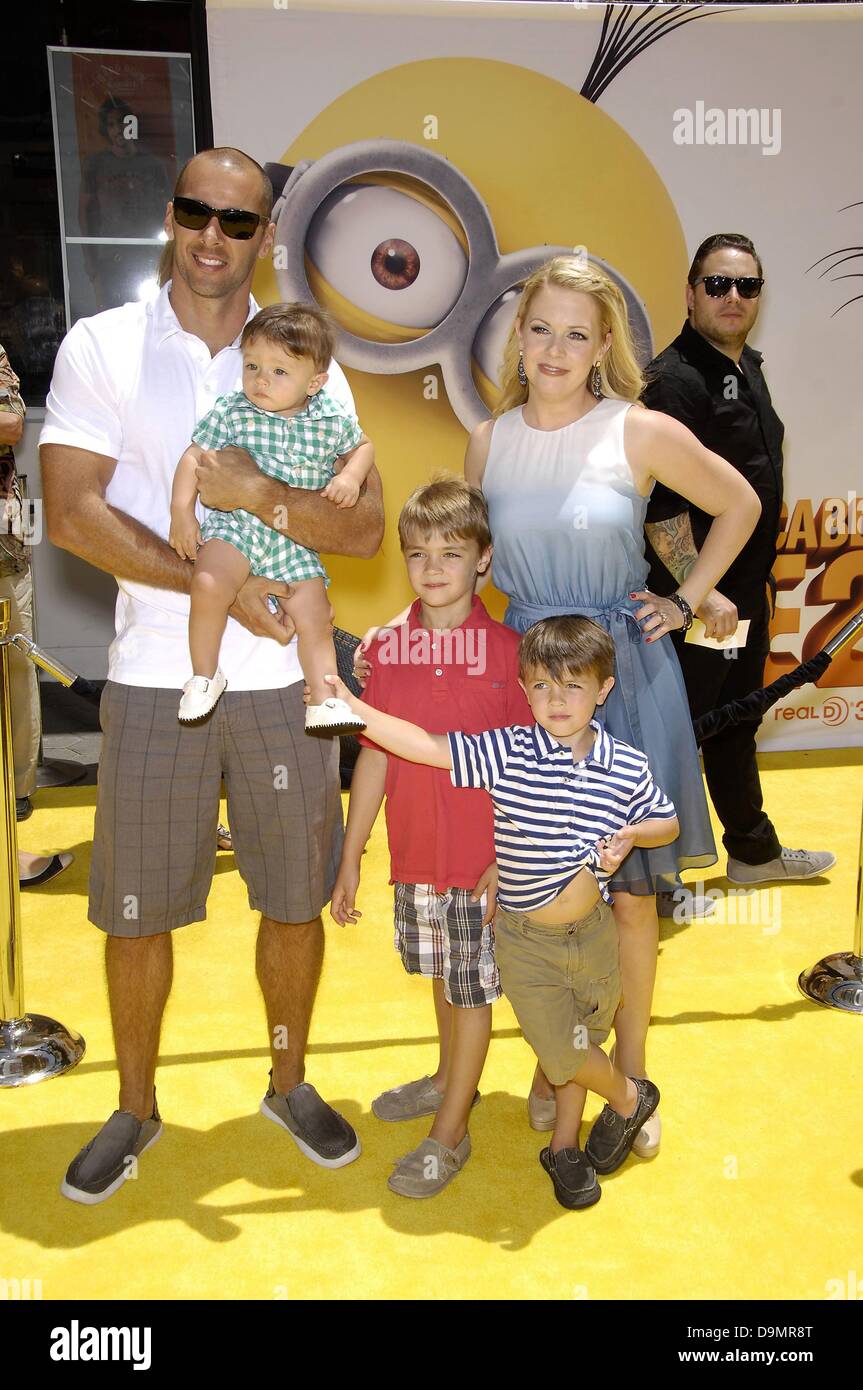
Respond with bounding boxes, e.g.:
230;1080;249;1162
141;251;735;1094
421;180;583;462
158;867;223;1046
208;0;863;749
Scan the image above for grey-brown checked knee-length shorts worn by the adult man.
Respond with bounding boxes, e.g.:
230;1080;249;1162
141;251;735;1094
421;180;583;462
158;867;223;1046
89;681;342;937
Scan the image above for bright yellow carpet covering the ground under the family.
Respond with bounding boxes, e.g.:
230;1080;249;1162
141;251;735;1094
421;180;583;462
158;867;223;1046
0;751;863;1300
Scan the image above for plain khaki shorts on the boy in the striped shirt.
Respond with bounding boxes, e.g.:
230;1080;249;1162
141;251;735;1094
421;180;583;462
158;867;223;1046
495;899;620;1086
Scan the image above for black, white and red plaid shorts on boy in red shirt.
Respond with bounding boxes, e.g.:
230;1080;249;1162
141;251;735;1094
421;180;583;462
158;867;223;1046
395;883;500;1009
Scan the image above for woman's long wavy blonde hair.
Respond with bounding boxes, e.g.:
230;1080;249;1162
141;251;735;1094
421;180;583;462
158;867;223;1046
495;256;643;416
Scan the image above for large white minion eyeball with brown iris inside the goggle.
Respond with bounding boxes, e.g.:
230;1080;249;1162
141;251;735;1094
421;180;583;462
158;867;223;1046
306;175;467;338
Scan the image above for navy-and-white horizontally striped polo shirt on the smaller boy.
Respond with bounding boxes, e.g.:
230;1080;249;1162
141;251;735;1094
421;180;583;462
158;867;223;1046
447;719;675;912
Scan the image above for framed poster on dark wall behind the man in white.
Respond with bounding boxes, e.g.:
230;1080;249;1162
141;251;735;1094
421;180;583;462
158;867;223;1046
47;47;195;328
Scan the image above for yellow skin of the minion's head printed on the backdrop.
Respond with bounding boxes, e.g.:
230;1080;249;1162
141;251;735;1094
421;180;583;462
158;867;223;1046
254;58;688;632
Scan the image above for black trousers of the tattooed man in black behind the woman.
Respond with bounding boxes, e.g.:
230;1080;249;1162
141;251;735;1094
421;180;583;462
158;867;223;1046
671;602;781;865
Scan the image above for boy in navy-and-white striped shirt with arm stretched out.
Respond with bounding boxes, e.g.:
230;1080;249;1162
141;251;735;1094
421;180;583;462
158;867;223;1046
316;616;680;1208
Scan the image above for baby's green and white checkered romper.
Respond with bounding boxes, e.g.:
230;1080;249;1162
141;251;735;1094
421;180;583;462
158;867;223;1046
192;391;363;584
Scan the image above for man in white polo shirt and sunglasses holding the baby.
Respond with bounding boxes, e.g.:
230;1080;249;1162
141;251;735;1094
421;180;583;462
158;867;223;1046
40;149;384;1204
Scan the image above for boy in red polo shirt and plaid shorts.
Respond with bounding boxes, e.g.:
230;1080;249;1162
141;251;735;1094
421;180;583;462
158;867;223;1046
329;478;534;1197
